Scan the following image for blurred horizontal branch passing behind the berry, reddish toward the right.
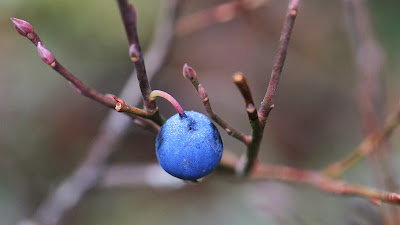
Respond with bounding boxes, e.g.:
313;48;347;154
99;151;400;205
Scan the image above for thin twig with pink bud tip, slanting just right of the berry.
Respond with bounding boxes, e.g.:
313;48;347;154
183;64;250;145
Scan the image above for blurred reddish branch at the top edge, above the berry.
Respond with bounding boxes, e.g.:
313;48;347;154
175;0;270;37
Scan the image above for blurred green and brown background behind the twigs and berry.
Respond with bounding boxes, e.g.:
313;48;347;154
0;0;400;225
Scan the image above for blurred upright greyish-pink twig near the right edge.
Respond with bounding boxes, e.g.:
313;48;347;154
343;0;400;221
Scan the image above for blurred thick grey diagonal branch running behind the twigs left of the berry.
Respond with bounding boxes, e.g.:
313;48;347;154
15;1;181;225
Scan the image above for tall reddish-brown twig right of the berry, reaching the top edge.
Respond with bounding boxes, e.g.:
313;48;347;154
258;0;300;126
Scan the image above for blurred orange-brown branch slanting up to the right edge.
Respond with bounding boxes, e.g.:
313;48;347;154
324;101;400;177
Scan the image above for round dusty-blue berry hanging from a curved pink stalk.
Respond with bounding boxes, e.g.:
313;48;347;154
156;111;223;180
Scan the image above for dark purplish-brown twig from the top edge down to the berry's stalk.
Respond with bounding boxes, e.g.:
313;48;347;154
117;0;158;112
